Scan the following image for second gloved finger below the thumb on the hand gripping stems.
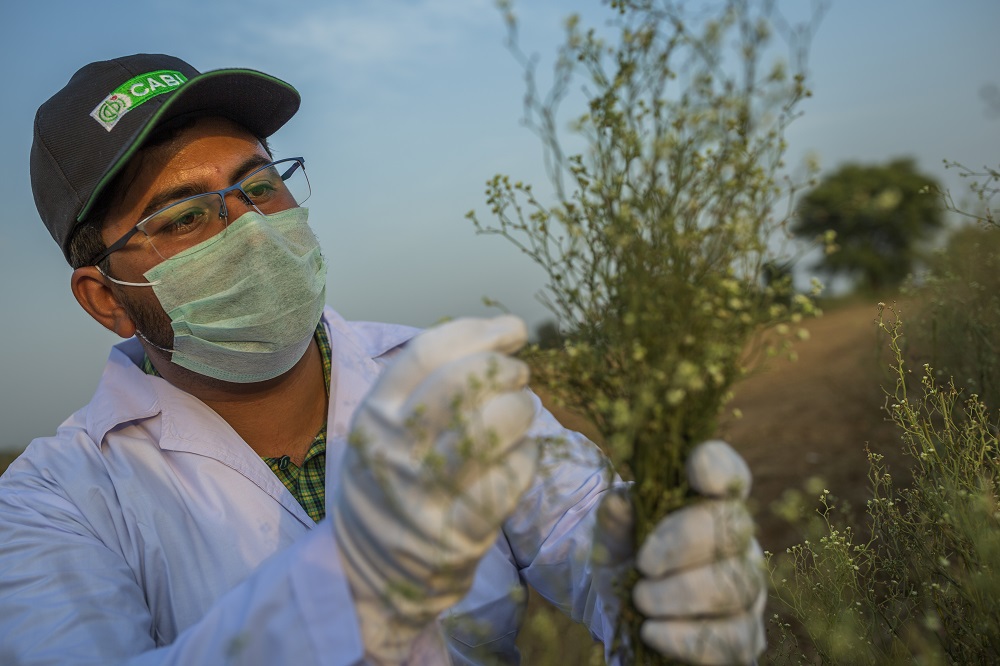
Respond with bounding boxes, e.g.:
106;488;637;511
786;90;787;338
632;536;767;619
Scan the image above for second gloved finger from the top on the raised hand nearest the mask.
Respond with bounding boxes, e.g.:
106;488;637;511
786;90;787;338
399;352;530;433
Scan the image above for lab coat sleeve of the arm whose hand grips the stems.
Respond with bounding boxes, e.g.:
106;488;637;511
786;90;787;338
504;398;622;645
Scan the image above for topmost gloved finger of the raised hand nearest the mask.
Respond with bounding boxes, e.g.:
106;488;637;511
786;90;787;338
369;315;528;413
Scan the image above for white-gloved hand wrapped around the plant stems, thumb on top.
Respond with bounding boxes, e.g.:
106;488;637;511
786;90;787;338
597;441;767;666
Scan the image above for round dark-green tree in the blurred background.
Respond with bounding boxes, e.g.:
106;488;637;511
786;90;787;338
792;158;944;290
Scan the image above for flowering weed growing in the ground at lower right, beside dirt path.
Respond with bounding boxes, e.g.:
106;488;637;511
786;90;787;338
768;304;1000;666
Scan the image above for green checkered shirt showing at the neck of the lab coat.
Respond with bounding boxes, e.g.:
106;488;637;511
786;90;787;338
142;322;332;523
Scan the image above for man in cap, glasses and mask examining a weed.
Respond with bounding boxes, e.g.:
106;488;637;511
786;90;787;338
0;55;765;664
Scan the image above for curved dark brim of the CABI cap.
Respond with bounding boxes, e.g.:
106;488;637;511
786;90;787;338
76;69;301;222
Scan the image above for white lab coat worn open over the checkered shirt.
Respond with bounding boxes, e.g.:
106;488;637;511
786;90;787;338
0;308;612;666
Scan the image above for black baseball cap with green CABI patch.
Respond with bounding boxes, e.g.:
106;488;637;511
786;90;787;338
31;53;300;261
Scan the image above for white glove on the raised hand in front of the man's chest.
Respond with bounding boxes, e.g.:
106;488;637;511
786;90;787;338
330;316;538;664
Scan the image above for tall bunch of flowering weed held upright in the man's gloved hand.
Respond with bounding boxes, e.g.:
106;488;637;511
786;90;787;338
469;0;814;664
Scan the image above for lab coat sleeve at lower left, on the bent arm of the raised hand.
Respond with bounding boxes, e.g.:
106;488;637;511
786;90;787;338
0;448;363;666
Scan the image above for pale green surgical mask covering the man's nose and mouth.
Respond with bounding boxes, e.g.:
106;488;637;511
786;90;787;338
137;208;326;383
